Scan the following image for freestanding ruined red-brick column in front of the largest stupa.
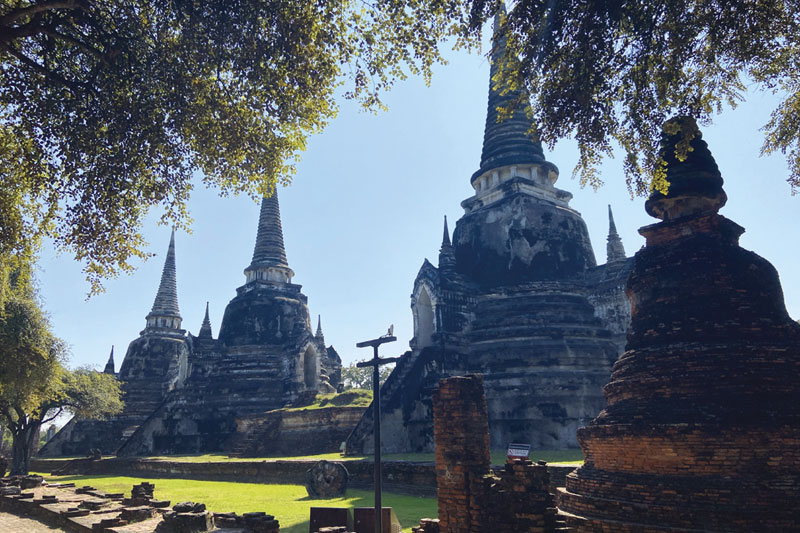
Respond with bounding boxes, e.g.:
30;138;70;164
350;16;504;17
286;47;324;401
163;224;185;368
433;375;491;533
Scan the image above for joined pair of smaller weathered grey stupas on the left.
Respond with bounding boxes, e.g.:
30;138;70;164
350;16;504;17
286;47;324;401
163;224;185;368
40;193;341;456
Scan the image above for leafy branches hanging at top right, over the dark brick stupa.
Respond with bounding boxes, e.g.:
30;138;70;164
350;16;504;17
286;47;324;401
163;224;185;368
464;0;800;194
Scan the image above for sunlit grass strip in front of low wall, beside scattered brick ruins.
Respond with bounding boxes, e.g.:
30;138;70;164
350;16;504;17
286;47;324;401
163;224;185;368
39;474;437;533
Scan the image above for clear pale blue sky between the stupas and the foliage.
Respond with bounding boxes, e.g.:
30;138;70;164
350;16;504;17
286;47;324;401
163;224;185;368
39;41;800;369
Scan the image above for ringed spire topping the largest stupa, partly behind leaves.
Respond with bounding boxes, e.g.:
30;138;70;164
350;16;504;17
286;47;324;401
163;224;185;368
472;3;555;184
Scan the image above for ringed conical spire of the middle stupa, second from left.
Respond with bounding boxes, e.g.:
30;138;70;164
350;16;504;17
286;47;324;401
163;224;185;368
244;190;294;283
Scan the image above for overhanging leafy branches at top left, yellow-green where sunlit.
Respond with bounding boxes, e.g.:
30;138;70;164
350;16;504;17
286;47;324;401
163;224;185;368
0;0;466;291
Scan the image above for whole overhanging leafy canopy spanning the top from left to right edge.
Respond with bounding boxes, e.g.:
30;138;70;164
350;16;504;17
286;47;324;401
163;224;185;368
0;0;800;298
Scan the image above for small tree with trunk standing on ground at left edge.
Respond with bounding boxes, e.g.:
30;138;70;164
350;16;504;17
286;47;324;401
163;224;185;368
0;272;122;474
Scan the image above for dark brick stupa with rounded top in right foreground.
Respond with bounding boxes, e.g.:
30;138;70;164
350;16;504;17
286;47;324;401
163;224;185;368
560;117;800;532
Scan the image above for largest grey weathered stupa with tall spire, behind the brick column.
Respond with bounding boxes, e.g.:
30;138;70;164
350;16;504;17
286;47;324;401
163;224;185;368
347;8;631;453
